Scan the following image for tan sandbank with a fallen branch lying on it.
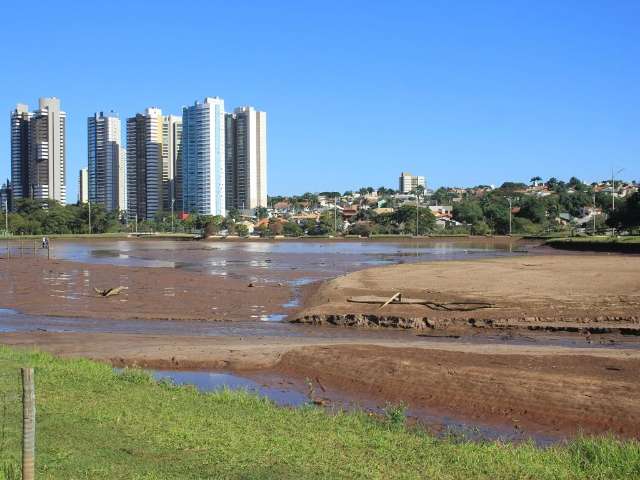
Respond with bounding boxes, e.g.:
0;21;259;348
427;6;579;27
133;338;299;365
295;255;640;334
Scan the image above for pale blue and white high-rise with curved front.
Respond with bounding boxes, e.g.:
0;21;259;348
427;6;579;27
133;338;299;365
182;97;226;215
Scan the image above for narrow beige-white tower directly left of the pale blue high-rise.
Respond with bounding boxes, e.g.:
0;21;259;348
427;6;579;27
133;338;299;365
162;115;182;211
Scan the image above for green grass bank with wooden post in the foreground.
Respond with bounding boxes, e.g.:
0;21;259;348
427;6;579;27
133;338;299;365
0;347;640;479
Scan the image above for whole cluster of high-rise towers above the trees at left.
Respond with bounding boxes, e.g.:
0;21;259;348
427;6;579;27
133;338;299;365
11;97;267;220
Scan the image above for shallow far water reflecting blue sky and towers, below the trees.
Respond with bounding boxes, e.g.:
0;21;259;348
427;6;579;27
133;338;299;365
46;239;522;285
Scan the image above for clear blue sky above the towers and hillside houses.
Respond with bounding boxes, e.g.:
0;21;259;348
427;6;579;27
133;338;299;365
0;0;640;201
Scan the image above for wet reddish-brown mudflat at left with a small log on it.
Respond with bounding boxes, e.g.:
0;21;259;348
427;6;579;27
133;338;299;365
0;257;292;320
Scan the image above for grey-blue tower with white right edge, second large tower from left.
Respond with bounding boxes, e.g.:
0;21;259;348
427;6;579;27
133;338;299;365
87;112;126;212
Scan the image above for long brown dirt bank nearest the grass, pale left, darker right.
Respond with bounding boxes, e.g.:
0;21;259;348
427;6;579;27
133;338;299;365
0;332;640;438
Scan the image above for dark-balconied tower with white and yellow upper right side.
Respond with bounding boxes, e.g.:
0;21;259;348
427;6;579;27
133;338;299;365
127;108;163;220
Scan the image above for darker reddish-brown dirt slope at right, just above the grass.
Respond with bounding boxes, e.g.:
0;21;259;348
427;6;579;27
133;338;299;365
276;345;640;438
